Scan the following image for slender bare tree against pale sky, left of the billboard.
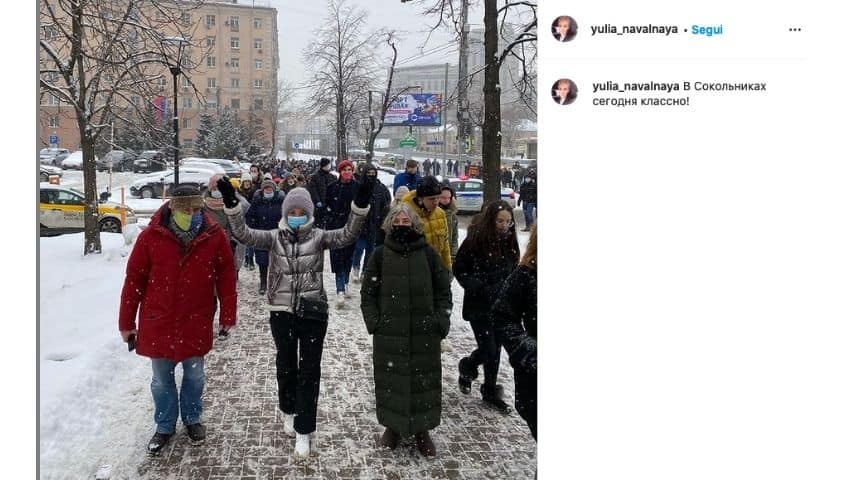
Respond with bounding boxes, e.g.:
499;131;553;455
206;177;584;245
303;0;377;160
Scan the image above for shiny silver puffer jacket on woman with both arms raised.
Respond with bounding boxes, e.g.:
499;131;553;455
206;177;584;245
225;200;370;313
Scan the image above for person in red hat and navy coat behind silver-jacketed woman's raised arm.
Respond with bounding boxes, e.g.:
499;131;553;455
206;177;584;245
324;160;360;308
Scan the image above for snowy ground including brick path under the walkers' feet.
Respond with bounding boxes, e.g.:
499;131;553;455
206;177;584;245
39;230;536;479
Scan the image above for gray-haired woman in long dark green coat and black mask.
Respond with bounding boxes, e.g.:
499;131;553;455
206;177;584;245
362;203;452;457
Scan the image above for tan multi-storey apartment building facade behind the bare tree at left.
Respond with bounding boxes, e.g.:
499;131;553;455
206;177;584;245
38;0;279;155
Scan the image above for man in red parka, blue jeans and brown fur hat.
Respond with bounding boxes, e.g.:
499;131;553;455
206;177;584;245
119;185;237;455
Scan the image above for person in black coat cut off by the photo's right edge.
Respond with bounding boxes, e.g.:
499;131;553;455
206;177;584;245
492;223;537;440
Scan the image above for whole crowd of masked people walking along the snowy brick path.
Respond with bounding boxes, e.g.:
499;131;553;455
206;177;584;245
118;154;537;458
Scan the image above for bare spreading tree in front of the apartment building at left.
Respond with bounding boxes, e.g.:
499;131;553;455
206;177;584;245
39;0;202;255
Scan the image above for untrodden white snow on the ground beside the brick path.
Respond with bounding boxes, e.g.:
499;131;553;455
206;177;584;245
38;208;528;479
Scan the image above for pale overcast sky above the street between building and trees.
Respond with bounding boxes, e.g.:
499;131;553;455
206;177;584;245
266;0;483;104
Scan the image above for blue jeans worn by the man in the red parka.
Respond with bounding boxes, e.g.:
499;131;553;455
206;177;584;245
151;357;205;434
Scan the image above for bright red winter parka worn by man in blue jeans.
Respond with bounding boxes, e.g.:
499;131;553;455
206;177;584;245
119;204;237;362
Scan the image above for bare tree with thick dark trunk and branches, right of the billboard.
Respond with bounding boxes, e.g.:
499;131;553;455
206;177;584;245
400;0;537;202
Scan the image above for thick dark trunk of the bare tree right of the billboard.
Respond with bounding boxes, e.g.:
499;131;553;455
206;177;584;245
482;0;501;204
